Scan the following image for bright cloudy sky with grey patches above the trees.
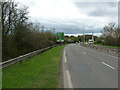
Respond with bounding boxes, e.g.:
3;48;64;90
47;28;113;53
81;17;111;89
15;0;118;35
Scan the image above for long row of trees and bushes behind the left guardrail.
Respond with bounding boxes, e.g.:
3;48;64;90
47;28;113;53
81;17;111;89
0;1;56;61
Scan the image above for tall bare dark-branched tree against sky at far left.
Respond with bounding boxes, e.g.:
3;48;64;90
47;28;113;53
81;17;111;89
1;1;28;39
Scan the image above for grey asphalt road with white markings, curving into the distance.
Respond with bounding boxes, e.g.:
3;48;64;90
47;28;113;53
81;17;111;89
62;44;118;88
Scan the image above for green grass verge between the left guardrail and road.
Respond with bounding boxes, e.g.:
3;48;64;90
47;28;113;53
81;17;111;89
3;45;65;88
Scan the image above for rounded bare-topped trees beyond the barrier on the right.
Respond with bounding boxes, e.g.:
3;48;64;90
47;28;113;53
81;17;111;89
96;22;120;46
